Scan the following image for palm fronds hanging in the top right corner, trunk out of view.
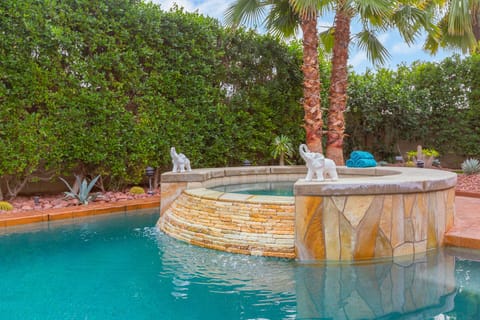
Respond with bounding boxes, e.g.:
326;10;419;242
424;0;480;54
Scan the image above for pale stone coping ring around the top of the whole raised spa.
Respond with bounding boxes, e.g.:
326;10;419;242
161;166;457;198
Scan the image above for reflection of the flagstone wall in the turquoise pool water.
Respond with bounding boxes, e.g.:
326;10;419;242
295;252;456;320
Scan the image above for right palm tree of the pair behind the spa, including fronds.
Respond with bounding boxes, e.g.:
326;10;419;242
291;0;428;165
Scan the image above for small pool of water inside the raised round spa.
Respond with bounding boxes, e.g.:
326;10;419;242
212;181;295;197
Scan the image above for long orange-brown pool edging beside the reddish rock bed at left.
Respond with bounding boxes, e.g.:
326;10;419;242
0;196;160;228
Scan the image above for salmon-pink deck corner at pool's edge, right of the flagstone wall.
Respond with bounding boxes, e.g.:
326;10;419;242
445;196;480;249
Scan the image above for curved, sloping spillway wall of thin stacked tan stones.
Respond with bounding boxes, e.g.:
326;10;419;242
159;189;295;258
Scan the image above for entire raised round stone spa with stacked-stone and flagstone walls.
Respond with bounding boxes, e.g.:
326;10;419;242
157;166;456;261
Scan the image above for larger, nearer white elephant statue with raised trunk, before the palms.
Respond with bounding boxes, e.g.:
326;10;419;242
299;144;338;181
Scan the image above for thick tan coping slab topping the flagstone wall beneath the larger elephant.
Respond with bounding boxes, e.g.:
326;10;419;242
294;167;457;196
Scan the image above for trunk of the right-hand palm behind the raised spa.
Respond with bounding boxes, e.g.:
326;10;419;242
327;8;351;166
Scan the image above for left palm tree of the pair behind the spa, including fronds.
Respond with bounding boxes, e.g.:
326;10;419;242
225;0;328;152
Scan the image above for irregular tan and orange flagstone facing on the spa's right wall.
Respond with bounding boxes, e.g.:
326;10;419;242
295;188;455;260
